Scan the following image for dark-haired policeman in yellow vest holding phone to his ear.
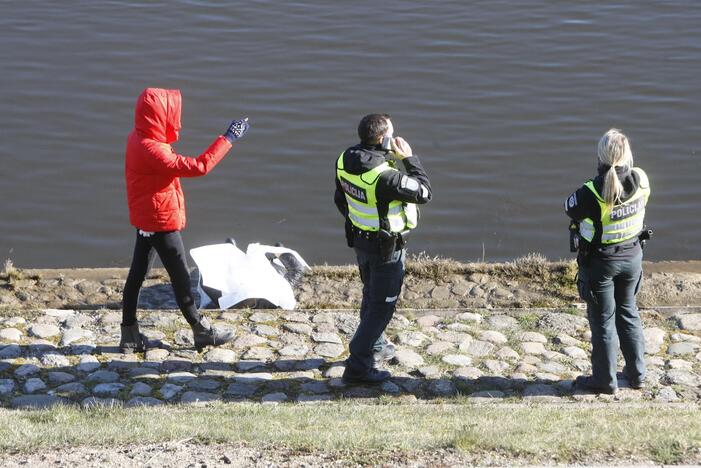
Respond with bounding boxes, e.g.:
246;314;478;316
334;114;431;383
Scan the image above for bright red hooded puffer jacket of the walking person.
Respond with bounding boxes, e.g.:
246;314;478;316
125;88;231;232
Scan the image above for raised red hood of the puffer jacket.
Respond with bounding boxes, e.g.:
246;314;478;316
134;88;182;144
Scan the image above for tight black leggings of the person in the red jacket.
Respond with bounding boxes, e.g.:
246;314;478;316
122;230;200;326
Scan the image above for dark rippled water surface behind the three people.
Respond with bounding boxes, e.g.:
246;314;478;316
0;0;701;267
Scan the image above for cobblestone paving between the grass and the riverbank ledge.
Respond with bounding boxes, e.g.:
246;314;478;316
0;308;701;408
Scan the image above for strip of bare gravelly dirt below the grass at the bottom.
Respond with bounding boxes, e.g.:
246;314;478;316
3;440;680;468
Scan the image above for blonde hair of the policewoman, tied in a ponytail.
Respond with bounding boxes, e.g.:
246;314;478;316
598;128;633;207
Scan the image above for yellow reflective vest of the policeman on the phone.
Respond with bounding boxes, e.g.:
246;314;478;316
336;153;418;232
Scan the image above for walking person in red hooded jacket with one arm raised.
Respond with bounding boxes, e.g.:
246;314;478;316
119;88;249;352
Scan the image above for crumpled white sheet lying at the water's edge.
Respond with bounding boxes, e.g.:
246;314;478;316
190;243;309;309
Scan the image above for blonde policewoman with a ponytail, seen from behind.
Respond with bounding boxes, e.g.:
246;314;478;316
565;129;651;394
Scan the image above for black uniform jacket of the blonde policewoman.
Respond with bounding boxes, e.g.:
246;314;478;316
565;166;640;259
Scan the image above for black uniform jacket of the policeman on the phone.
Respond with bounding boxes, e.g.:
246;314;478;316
334;145;432;246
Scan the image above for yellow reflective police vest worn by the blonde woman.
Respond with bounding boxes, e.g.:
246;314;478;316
579;167;650;245
